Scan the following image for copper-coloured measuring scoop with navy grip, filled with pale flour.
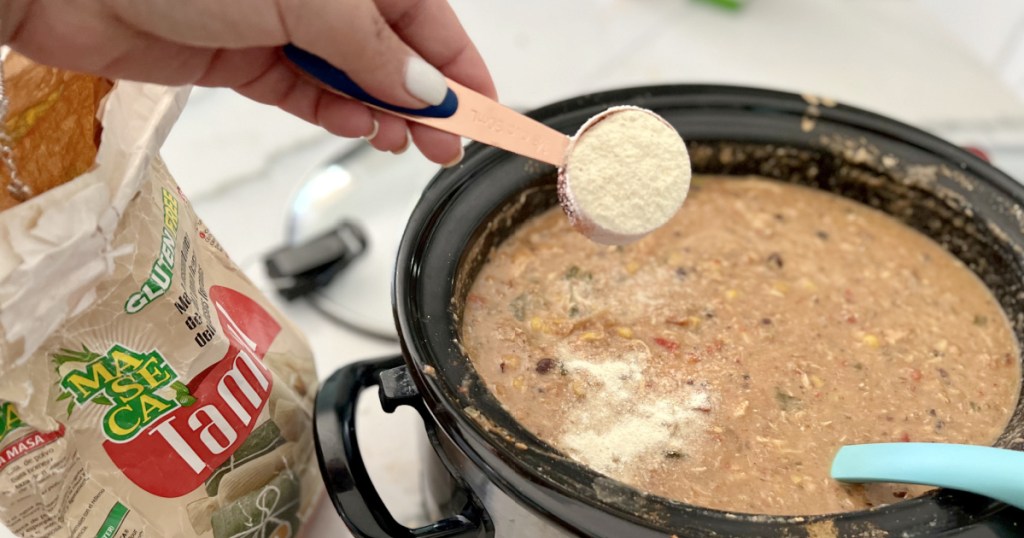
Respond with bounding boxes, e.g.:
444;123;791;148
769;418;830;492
283;45;690;244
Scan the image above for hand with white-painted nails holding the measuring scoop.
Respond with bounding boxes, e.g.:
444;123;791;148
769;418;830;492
0;0;497;164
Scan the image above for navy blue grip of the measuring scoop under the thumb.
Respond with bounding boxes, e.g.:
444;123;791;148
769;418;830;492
282;44;459;118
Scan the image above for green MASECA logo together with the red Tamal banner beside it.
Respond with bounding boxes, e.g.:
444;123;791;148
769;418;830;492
61;286;281;497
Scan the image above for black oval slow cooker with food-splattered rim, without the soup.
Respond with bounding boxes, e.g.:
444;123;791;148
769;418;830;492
315;85;1024;538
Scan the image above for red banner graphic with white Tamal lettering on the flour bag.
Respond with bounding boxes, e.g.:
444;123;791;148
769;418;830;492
103;286;281;497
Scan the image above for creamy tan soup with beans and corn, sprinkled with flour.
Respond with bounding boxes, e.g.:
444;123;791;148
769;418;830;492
462;174;1021;514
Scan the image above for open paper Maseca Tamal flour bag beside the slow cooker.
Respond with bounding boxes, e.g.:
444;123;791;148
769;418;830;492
0;54;323;538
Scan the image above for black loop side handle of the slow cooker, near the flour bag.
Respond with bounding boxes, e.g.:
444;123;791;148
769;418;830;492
313;356;485;538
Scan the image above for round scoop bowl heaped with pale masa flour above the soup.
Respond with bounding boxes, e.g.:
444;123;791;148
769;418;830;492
559;107;691;244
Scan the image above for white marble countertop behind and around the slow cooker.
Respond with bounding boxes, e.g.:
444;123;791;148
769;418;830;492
0;0;1024;538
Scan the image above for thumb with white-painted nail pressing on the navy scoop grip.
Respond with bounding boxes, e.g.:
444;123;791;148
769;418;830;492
280;0;447;108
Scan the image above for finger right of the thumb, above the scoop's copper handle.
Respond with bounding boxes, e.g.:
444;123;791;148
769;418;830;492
376;0;498;99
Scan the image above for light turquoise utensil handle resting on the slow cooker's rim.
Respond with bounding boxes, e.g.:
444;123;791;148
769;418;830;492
831;443;1024;509
